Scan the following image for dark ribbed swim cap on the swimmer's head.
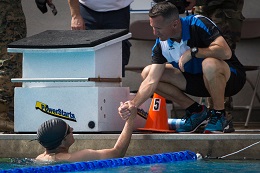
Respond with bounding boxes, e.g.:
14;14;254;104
37;118;69;150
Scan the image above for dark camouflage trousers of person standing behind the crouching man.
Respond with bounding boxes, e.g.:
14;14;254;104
195;0;245;50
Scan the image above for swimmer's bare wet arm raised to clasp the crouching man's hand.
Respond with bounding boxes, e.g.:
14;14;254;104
69;101;137;162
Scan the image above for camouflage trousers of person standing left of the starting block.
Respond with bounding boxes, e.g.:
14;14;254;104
0;0;26;106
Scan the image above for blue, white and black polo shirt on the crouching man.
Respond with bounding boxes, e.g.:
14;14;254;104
152;15;242;74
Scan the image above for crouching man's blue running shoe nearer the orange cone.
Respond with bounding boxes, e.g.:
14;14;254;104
176;105;208;133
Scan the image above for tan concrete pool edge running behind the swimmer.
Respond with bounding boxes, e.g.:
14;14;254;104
0;123;260;159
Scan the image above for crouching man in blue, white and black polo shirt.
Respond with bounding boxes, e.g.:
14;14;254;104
119;1;246;133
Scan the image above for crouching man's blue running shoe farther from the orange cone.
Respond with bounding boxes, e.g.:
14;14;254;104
204;110;227;133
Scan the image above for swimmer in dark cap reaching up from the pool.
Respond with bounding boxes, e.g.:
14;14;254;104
36;101;137;162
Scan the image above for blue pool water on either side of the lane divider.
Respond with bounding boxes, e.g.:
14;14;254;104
0;159;260;173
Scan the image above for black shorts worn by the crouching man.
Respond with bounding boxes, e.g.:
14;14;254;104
183;71;246;97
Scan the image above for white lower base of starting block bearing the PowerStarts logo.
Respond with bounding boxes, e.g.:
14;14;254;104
14;87;150;132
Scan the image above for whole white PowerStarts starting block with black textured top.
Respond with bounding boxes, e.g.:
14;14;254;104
8;30;150;132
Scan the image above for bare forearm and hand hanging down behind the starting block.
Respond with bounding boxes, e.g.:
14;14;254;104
68;0;85;30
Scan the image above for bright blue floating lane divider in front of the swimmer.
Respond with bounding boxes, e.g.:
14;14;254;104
0;150;197;173
